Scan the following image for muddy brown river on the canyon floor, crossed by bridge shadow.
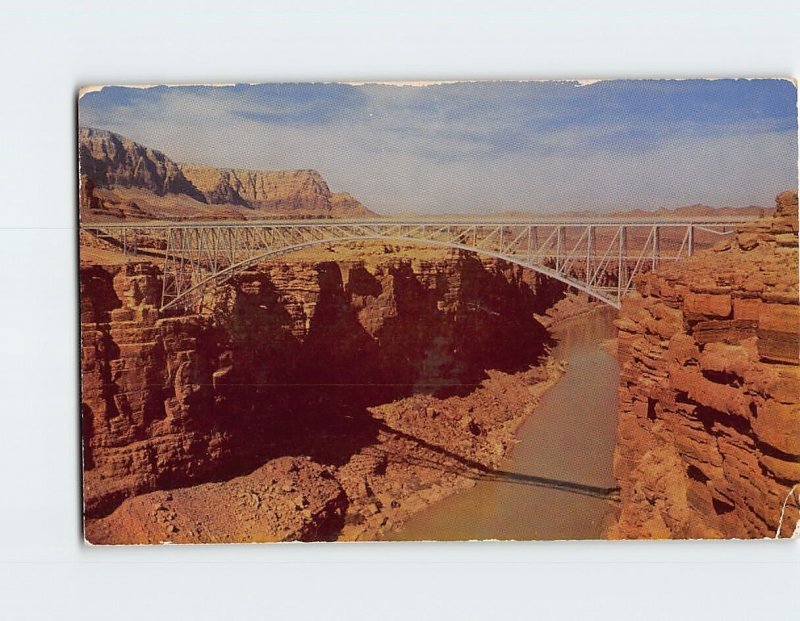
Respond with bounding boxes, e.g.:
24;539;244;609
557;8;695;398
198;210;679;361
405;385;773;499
383;308;619;541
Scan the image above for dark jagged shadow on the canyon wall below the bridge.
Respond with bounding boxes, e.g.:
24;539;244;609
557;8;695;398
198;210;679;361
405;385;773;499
211;257;563;478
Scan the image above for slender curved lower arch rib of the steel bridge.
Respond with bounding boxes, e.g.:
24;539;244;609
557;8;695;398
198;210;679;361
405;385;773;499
161;234;621;311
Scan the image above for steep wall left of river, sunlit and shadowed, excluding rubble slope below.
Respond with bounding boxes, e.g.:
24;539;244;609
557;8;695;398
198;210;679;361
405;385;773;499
81;249;563;541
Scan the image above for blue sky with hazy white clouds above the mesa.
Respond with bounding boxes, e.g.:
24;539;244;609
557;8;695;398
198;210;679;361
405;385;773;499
78;80;798;214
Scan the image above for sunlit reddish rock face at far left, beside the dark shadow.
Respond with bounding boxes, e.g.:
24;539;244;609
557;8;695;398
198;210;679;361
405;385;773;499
81;263;225;515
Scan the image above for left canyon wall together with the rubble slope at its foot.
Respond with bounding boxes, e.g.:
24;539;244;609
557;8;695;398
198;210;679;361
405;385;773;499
81;253;563;542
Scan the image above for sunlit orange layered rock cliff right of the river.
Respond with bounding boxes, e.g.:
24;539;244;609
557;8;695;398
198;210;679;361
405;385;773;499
611;192;800;538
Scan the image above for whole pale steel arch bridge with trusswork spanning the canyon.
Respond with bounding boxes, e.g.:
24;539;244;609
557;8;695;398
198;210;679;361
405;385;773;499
81;216;756;311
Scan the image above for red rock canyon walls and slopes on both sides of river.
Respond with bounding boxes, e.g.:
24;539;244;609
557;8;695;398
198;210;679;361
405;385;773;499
80;182;800;543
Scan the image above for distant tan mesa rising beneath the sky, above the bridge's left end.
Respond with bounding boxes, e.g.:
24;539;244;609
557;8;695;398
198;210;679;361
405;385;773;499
78;128;376;220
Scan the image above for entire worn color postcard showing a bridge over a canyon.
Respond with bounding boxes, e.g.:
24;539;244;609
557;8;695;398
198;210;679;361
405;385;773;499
76;79;800;544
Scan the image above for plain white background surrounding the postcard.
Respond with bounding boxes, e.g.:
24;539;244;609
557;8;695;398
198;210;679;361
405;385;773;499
0;0;800;620
